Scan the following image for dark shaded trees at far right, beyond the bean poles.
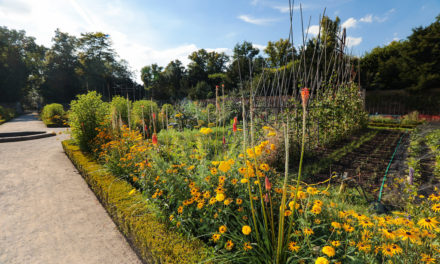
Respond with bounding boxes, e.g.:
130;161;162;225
360;16;440;91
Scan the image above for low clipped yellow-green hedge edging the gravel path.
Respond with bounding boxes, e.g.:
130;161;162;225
62;140;212;263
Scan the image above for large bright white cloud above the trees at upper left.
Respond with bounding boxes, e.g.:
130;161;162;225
0;0;232;82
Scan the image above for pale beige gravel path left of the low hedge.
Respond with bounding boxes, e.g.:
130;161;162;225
0;114;141;264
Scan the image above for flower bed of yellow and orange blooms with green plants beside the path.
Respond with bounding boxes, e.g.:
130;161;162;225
59;85;440;263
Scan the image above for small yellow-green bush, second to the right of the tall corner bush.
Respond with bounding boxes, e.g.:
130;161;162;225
131;100;159;132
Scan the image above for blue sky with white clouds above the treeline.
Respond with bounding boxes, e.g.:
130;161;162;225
0;0;440;80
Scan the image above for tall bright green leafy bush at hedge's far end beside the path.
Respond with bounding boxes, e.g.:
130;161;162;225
69;91;108;151
